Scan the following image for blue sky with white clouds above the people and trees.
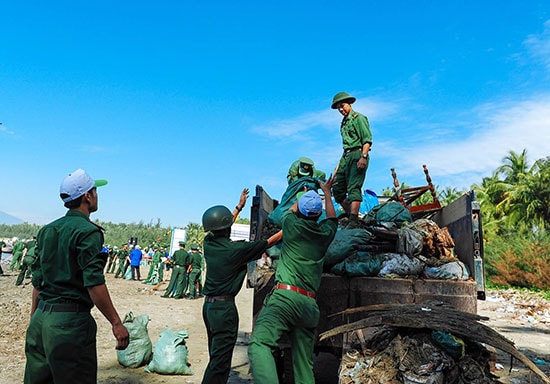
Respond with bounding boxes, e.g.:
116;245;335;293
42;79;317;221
0;0;550;226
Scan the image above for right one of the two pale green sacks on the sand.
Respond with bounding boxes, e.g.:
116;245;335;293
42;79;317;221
145;328;193;375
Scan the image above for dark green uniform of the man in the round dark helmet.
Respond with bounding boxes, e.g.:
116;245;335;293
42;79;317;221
202;235;267;384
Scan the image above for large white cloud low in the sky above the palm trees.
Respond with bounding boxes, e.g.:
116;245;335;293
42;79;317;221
378;95;550;186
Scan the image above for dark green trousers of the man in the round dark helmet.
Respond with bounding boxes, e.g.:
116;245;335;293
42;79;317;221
202;301;238;384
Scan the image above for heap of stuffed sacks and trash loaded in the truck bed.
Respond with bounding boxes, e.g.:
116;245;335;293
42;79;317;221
252;201;470;286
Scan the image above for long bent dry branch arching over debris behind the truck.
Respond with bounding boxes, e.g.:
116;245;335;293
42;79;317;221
319;302;550;384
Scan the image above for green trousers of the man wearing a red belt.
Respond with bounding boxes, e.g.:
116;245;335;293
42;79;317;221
248;290;319;384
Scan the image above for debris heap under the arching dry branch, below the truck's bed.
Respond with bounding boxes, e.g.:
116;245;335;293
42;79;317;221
320;302;550;384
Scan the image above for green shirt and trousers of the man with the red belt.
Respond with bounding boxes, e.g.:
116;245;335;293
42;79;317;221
248;211;338;384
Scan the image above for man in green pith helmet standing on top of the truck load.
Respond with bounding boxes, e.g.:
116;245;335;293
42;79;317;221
332;92;372;229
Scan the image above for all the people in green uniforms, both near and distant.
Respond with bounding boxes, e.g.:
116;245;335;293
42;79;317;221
10;92;372;384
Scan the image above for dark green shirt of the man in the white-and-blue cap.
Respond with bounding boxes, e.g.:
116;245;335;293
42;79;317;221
32;210;106;308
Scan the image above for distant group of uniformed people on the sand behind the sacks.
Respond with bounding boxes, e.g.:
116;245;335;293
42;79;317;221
104;242;204;299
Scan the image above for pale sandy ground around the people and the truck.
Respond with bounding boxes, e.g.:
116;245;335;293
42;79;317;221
0;264;550;384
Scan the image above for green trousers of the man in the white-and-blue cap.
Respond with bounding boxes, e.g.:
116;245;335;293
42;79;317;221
24;309;97;384
